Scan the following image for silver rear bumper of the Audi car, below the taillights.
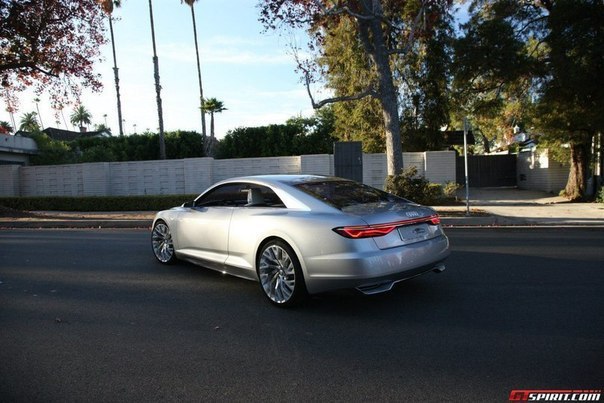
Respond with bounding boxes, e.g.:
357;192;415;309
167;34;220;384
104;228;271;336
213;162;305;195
305;235;450;294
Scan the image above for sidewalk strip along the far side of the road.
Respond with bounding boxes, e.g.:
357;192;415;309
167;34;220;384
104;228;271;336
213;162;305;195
0;188;604;229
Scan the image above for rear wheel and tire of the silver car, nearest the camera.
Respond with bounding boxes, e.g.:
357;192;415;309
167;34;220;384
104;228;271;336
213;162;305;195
256;239;307;307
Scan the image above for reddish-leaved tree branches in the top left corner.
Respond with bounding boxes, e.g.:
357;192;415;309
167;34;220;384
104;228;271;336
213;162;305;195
0;0;106;109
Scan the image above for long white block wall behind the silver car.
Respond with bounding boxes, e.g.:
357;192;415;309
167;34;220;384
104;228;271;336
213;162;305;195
0;151;455;196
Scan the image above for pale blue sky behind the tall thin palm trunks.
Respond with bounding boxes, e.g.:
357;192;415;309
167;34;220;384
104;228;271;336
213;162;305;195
0;0;313;138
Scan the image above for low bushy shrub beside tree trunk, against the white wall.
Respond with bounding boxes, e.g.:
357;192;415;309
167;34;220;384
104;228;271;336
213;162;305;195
386;166;444;205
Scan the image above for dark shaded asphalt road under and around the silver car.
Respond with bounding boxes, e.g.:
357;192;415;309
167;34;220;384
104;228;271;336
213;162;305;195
0;228;604;402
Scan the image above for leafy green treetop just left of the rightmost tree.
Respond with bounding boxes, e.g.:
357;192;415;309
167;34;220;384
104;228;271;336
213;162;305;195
453;3;541;150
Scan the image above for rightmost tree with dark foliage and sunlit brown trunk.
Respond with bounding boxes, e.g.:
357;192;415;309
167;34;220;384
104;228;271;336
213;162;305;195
537;0;604;199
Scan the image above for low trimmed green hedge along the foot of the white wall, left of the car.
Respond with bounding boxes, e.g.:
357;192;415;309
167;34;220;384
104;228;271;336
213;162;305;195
0;195;198;215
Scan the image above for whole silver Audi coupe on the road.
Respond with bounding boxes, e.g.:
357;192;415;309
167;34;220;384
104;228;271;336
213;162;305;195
151;175;449;306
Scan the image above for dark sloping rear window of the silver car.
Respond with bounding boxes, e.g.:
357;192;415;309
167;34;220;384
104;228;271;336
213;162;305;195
294;180;406;210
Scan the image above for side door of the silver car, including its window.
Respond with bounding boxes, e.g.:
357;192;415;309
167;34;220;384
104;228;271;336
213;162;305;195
178;183;247;269
